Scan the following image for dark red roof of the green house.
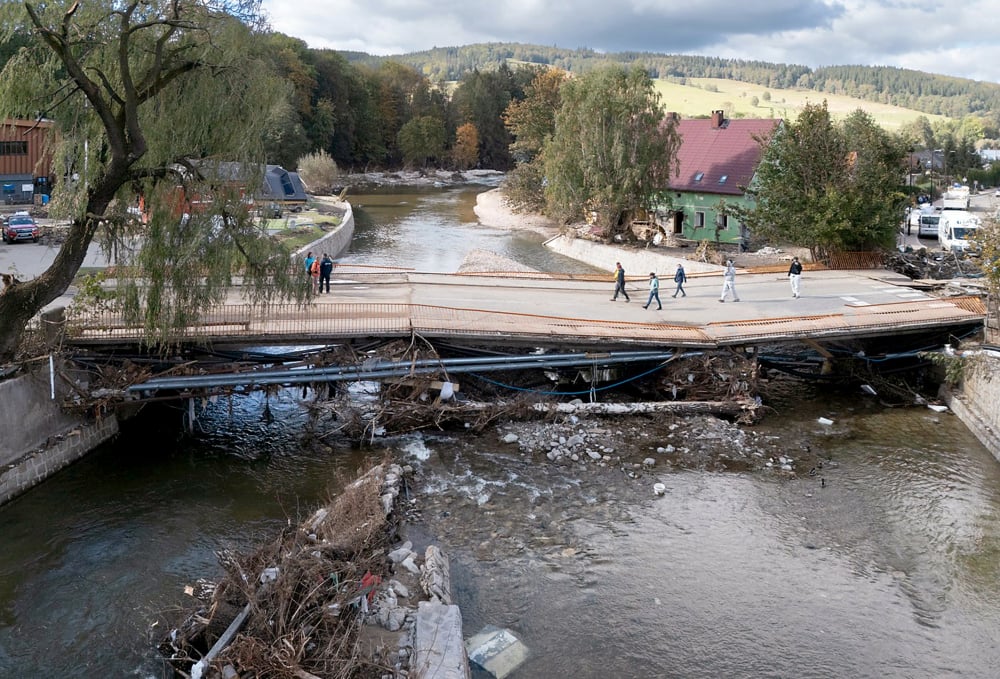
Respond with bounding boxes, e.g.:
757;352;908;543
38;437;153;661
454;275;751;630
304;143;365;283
670;118;780;195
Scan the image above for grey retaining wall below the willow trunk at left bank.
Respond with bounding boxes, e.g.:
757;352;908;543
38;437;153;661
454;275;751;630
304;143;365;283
0;365;118;504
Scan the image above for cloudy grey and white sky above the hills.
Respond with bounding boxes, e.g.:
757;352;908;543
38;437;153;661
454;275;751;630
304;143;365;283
264;0;1000;82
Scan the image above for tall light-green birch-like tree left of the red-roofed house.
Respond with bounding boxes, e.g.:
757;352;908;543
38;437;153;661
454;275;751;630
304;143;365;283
543;66;680;232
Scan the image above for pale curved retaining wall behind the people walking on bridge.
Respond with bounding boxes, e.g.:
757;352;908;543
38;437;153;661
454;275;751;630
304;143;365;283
545;235;723;284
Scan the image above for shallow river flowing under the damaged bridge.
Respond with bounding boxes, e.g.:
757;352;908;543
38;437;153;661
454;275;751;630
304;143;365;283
0;188;1000;679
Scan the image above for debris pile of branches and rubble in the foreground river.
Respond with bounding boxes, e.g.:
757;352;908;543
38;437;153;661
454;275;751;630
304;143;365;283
160;464;450;679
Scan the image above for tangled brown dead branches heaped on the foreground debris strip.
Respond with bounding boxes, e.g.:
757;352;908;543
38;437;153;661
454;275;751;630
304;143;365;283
161;467;392;679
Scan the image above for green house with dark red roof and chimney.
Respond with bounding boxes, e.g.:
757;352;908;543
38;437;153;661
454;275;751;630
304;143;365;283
659;111;781;243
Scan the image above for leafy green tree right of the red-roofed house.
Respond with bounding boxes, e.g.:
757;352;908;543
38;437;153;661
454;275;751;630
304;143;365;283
734;102;908;260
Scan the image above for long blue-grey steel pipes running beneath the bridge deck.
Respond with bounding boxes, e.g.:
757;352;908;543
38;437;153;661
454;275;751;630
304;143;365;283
128;351;690;393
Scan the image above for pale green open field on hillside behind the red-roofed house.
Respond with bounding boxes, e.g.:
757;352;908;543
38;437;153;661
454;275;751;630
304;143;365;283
654;78;944;130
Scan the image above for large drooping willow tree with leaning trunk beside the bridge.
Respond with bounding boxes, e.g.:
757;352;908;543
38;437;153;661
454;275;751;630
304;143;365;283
0;0;305;358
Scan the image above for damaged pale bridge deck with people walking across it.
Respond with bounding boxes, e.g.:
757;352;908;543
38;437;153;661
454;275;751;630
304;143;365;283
62;269;986;348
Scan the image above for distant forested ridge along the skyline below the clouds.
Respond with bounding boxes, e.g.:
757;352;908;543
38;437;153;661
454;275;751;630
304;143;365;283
342;43;1000;121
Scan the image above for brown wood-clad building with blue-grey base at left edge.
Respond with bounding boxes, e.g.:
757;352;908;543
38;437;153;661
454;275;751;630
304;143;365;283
0;119;54;205
